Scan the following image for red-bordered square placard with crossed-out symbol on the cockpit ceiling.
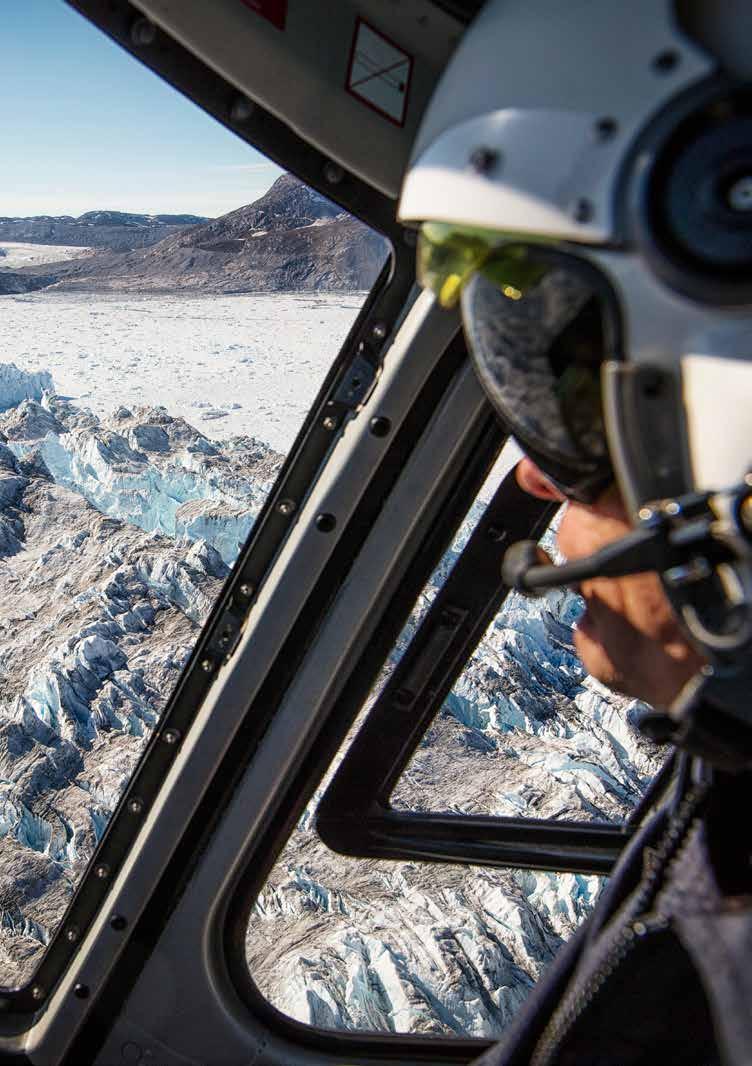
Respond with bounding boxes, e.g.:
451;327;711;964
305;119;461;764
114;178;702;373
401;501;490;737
347;18;413;126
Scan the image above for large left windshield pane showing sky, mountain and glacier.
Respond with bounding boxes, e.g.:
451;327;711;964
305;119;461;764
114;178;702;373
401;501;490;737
0;0;387;986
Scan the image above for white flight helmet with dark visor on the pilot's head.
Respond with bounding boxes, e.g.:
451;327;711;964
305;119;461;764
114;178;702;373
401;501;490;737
399;0;752;763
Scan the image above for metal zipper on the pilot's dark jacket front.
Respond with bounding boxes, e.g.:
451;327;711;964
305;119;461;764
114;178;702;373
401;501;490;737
530;784;708;1066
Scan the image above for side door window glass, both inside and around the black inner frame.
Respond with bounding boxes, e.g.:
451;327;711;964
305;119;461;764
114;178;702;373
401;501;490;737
246;447;640;1037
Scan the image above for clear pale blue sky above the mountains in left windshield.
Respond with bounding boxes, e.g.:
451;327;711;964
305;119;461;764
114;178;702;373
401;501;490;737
0;0;282;216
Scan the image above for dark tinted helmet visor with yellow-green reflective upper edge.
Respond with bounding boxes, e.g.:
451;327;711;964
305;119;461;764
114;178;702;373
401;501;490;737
418;223;613;502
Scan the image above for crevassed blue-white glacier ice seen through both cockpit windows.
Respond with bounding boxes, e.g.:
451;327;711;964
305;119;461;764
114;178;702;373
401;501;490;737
0;368;657;1037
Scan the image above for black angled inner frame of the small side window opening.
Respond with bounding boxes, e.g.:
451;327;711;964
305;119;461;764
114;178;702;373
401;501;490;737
316;471;633;875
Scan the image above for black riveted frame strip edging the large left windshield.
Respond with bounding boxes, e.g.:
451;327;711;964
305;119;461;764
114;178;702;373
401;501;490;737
0;0;415;1019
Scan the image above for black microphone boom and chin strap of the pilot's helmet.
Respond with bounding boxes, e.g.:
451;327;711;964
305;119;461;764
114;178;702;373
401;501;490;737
501;475;752;772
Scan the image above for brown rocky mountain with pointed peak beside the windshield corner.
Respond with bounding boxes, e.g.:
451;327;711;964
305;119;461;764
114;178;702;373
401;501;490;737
19;175;387;293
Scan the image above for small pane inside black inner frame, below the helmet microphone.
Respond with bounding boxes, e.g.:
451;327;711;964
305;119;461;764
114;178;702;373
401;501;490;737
391;567;661;821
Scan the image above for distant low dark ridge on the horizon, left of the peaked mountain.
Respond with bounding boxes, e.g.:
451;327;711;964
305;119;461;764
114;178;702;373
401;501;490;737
0;211;207;252
